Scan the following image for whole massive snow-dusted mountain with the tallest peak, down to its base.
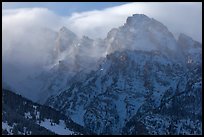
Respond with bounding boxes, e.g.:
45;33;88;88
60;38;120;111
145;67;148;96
45;14;202;134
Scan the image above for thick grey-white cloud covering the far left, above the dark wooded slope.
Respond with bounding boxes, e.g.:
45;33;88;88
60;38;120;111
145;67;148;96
2;8;61;95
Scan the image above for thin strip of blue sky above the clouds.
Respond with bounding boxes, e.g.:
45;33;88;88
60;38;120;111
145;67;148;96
3;2;127;16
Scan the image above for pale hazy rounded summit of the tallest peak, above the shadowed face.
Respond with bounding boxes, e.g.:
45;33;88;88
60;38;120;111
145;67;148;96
106;14;178;55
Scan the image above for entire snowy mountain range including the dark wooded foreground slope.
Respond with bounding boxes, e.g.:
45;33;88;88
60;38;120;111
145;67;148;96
2;14;202;135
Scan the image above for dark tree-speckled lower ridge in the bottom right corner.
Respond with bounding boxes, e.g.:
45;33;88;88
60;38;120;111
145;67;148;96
123;62;202;135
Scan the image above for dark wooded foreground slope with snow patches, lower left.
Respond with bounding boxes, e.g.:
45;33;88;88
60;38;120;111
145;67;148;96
2;89;93;135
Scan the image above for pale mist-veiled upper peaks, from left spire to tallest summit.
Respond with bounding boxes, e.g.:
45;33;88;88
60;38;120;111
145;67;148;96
39;14;184;102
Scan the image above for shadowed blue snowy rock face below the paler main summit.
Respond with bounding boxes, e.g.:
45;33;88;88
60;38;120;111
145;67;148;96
47;51;194;134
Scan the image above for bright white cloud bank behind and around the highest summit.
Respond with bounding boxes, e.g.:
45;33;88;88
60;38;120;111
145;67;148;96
64;2;202;42
